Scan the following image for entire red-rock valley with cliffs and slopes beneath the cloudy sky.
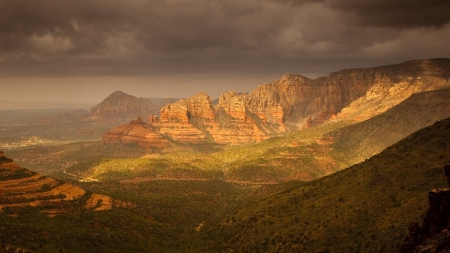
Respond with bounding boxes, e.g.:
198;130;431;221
0;59;450;252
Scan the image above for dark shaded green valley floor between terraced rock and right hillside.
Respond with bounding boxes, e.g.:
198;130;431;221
0;180;248;252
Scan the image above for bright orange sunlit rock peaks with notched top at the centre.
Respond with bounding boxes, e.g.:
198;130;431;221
158;92;268;144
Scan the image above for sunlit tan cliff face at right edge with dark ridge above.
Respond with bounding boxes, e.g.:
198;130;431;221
331;59;450;122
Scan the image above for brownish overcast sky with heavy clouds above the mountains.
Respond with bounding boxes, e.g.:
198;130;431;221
0;0;450;104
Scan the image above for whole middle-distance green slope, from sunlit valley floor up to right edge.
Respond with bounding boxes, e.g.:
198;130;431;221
68;89;450;183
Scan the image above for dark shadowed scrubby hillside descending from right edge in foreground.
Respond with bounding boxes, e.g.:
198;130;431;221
210;119;450;252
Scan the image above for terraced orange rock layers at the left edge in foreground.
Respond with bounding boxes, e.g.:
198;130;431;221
0;151;113;216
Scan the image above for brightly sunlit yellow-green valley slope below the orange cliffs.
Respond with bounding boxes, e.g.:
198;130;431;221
67;123;344;183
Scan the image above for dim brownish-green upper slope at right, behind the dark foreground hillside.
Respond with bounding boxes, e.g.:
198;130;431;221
326;89;450;164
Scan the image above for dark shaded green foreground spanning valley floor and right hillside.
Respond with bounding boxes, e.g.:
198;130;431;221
0;119;450;252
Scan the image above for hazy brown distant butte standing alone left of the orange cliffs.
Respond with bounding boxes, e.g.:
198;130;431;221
91;91;159;122
